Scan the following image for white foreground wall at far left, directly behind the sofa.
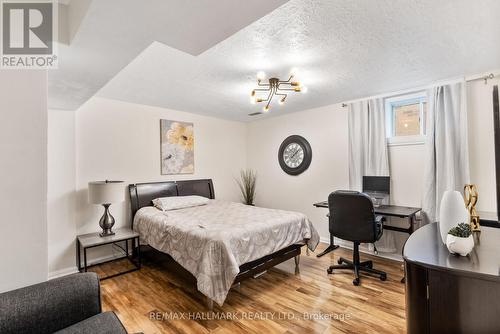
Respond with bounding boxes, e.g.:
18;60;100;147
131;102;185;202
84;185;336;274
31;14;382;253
0;70;47;292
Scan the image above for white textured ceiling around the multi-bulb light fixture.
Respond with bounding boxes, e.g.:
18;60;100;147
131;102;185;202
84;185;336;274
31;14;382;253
49;0;500;121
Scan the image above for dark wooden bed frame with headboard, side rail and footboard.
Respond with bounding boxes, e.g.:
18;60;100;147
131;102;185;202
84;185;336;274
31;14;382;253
129;179;304;308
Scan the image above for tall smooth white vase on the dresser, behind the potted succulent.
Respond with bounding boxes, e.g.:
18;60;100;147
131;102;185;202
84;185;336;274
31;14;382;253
439;190;469;244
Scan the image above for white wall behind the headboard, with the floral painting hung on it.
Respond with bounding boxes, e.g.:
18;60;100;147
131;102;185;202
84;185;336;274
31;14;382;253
68;97;246;264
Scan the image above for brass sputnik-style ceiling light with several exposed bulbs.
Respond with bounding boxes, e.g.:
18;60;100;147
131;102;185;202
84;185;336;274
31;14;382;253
248;71;307;116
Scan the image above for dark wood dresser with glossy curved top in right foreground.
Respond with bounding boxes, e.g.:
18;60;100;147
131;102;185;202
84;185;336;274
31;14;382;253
403;223;500;334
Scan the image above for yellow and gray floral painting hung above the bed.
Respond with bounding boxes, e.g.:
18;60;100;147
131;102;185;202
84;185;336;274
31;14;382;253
160;119;194;175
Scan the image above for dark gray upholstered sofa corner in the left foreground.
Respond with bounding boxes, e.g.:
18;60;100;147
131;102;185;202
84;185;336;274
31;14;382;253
0;273;127;334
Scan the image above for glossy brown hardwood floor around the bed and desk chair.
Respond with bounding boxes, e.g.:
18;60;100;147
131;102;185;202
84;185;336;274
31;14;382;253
96;244;405;334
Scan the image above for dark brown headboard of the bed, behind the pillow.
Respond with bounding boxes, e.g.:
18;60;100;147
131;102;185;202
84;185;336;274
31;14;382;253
128;179;215;224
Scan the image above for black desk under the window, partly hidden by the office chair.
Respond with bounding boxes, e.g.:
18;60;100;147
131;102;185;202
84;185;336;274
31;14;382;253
313;201;422;257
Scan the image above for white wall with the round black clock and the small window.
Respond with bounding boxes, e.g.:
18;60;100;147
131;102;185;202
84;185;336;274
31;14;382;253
247;79;500;254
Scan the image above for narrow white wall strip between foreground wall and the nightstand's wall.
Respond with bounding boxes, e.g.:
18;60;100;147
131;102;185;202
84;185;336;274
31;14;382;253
47;110;76;277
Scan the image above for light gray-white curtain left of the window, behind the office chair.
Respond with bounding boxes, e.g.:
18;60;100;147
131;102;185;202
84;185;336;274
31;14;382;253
348;98;396;252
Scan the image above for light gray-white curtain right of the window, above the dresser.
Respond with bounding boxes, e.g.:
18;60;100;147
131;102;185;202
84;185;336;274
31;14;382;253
422;82;469;223
